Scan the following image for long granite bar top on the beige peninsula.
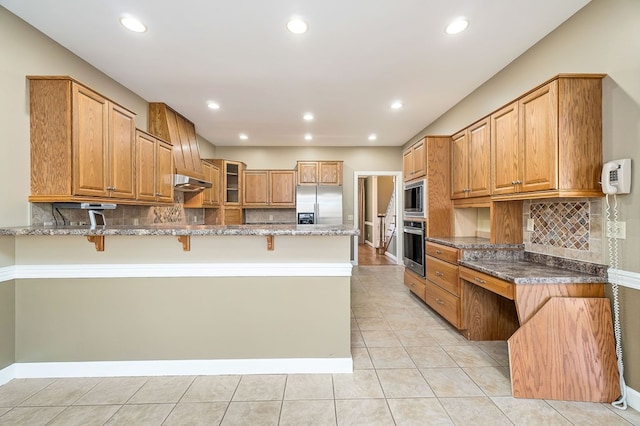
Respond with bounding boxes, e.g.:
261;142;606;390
0;223;360;236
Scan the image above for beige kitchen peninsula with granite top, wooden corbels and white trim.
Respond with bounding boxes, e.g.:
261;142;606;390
0;224;358;377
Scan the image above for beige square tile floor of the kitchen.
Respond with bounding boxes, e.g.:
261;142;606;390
0;266;640;426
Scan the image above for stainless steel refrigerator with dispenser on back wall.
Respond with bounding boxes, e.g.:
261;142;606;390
296;185;342;225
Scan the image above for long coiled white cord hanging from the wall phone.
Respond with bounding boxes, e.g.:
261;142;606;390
606;194;627;410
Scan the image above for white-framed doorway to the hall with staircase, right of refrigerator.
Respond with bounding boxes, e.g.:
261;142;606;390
353;171;402;265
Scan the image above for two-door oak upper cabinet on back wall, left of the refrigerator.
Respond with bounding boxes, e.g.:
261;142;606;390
243;170;296;208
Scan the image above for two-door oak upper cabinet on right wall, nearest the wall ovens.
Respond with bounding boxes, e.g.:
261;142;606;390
451;117;490;199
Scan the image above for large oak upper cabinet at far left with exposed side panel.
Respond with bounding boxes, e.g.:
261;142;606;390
28;76;136;202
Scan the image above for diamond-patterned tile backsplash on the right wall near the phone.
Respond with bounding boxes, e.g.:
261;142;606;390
523;198;604;263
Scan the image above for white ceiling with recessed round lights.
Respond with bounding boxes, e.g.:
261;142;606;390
0;0;590;146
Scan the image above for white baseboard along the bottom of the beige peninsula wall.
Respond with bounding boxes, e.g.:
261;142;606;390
0;358;353;384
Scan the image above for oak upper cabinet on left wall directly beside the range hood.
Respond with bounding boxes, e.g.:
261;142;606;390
136;130;173;203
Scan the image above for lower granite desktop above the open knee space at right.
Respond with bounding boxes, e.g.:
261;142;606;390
458;259;607;284
